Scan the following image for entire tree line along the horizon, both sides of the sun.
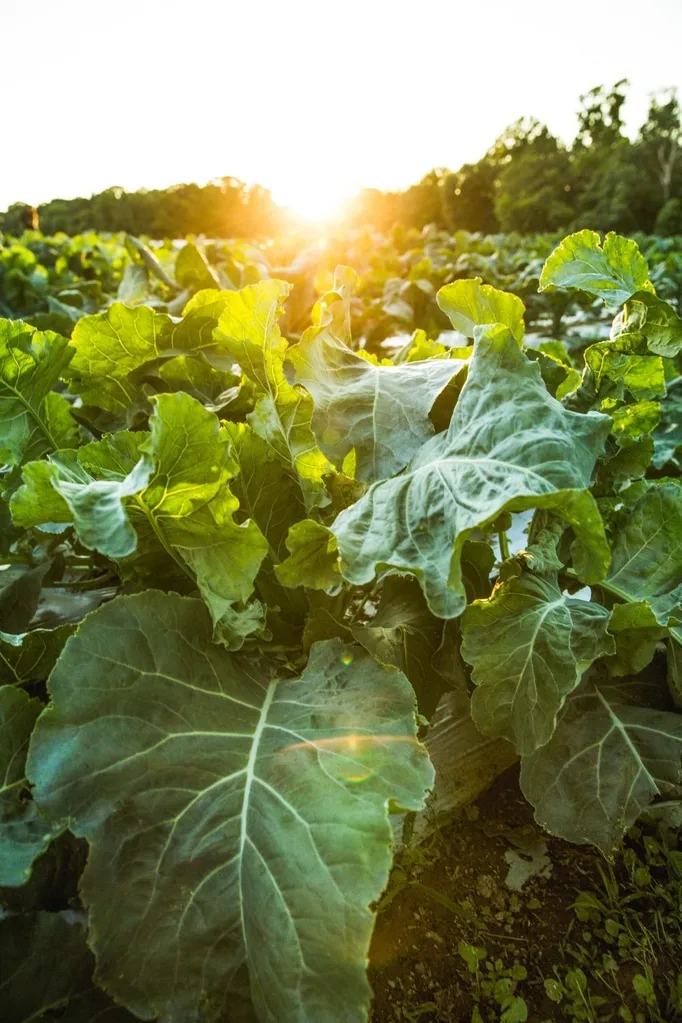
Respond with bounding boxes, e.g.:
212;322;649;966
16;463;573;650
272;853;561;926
0;80;682;238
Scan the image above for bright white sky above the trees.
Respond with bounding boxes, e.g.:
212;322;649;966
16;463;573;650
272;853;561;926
0;0;682;216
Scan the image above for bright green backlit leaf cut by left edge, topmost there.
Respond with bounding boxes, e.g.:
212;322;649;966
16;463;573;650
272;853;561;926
0;319;78;465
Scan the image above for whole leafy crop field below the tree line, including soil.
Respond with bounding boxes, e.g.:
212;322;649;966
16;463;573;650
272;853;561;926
0;226;682;1023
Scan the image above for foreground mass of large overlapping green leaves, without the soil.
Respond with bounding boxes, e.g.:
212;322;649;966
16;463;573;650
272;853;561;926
0;231;682;1023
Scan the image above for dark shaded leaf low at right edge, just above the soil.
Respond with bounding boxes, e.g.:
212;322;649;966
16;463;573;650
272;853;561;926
520;682;682;854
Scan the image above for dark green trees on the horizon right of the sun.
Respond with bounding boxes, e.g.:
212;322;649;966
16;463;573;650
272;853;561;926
353;80;682;235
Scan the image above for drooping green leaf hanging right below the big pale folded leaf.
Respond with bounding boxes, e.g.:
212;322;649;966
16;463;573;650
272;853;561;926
462;572;615;755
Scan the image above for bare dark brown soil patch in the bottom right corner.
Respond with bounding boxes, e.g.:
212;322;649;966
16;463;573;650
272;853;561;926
369;767;679;1023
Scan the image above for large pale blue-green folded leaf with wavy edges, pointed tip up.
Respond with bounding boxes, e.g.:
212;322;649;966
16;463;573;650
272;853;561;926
332;326;610;618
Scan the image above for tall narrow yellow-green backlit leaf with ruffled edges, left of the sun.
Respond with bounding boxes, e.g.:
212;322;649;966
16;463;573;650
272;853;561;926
214;280;332;512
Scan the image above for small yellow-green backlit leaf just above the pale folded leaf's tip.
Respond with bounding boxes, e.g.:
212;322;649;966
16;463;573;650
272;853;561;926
438;277;526;343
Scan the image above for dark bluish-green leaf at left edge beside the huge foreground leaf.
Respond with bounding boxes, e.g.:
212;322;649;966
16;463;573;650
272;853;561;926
0;685;62;887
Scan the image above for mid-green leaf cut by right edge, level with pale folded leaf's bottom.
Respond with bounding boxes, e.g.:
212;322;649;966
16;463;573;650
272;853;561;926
604;483;682;625
